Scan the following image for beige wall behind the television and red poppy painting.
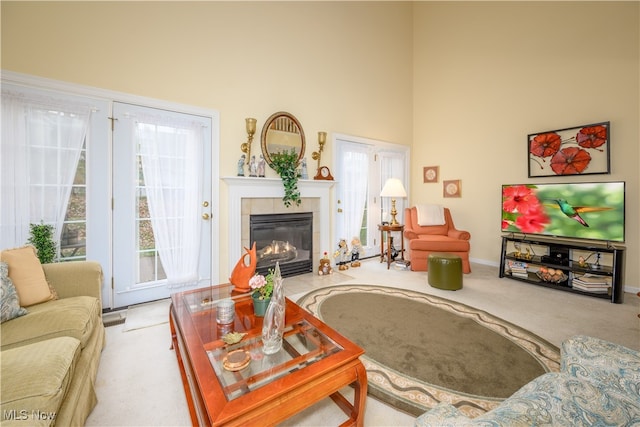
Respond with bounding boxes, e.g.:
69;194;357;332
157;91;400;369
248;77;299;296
411;2;640;287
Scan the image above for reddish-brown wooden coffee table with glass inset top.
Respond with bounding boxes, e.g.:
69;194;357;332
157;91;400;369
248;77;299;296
169;285;367;426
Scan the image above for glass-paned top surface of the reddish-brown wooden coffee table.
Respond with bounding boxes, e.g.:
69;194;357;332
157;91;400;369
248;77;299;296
173;284;343;401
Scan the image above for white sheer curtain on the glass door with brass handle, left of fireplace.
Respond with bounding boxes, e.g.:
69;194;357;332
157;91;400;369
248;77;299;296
134;115;205;287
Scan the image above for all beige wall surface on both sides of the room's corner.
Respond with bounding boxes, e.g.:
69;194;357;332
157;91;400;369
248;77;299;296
1;1;640;287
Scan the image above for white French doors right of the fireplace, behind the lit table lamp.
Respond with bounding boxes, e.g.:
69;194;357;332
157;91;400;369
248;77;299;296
334;135;409;256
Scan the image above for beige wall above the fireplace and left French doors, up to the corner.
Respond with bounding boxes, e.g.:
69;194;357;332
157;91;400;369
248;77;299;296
2;1;413;281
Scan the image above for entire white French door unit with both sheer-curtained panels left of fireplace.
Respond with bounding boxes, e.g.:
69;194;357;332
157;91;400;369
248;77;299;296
0;72;219;308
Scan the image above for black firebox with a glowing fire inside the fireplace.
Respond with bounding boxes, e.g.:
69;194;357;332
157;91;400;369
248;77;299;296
249;212;313;277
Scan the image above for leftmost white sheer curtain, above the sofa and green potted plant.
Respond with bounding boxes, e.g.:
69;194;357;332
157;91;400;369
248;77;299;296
0;86;91;252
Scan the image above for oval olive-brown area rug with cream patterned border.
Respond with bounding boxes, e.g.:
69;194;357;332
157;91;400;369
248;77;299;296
298;285;560;417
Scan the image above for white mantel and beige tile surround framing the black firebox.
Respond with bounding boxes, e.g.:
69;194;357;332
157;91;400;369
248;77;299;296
222;176;335;271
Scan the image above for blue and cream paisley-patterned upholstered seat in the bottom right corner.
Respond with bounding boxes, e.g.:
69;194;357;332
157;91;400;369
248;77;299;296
415;335;640;426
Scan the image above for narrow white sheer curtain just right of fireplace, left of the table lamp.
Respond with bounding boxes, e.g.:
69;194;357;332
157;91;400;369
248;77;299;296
336;143;370;242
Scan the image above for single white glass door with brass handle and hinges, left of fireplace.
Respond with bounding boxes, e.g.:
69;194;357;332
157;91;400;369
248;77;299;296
112;102;212;308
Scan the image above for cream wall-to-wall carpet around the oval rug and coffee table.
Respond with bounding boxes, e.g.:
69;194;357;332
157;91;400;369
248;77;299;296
85;259;640;427
